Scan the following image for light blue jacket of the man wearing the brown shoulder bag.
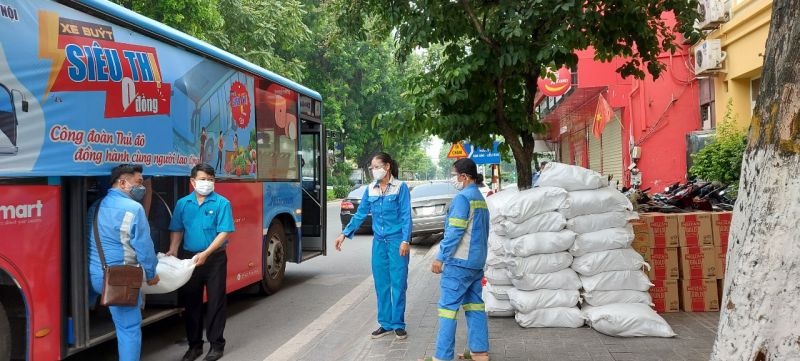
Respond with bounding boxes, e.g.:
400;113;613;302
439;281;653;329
87;188;158;280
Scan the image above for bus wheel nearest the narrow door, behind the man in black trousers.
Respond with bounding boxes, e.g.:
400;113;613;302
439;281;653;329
260;220;286;295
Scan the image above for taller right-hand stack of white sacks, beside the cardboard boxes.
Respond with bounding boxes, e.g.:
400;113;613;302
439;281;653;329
536;163;675;337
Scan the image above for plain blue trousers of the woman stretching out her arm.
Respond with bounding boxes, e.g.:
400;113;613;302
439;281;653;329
372;238;409;330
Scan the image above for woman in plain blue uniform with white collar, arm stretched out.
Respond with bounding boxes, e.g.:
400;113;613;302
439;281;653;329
336;153;411;340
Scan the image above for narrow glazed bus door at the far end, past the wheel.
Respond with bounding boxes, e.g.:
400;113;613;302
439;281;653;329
300;119;327;260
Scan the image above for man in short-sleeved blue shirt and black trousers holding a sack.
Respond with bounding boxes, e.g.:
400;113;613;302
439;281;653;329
167;163;234;361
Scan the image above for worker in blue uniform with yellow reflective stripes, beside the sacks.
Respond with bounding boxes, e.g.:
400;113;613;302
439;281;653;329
424;158;489;361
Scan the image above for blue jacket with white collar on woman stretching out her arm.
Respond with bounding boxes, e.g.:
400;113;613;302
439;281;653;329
342;177;411;242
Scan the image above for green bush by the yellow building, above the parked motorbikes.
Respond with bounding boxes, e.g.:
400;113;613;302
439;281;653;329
689;101;747;189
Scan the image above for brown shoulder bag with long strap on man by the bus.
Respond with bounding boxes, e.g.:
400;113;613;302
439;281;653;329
92;200;144;306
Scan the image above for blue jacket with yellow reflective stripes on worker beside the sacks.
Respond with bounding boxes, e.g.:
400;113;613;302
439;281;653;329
436;184;489;269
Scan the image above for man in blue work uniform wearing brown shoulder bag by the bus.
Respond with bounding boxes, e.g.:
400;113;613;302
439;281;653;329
87;164;159;361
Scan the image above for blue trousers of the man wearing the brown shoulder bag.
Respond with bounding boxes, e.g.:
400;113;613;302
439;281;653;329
91;276;142;361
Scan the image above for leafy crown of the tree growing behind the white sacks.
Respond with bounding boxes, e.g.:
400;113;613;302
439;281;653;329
338;0;698;186
